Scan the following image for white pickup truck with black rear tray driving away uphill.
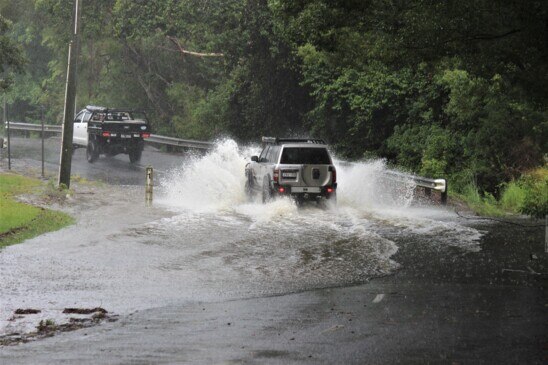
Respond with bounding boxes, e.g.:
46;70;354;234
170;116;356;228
72;106;150;163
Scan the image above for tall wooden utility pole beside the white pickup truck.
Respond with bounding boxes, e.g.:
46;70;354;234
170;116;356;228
59;0;82;188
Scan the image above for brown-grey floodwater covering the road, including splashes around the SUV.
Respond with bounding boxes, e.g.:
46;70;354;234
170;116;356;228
0;140;482;334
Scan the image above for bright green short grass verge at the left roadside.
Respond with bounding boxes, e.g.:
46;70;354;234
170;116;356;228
0;173;74;248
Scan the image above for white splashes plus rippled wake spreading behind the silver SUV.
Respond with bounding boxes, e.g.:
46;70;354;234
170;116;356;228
152;140;481;295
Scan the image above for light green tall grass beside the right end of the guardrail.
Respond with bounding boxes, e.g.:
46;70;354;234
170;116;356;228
453;167;548;218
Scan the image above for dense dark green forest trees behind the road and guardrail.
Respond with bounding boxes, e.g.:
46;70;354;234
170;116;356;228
0;0;548;202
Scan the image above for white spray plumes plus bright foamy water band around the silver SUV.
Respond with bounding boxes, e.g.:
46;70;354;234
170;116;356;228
156;140;481;253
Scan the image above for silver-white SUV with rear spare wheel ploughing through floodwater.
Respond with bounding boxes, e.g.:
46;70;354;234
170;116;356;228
245;137;337;203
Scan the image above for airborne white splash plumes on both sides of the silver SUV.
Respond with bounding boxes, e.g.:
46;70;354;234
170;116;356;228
159;140;415;216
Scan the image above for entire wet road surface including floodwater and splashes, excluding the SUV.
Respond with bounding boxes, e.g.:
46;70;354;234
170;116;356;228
0;136;548;364
